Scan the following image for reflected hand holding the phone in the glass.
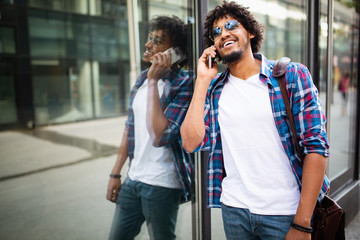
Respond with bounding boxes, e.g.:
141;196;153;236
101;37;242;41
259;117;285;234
147;51;171;80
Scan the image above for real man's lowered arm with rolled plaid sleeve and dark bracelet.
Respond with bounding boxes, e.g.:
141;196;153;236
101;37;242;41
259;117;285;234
286;65;329;239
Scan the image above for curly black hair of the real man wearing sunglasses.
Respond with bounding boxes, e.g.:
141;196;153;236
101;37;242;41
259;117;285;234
204;1;264;57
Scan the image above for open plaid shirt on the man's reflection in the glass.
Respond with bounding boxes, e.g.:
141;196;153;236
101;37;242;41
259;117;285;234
125;69;194;201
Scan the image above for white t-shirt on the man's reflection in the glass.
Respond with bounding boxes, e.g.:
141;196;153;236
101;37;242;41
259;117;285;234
128;79;180;188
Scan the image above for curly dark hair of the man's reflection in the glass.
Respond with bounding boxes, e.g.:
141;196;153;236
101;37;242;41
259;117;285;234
149;16;188;63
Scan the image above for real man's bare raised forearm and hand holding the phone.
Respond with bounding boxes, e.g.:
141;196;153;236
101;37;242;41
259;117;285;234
180;47;217;152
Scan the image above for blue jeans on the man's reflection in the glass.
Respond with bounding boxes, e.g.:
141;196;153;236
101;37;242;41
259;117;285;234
109;178;181;240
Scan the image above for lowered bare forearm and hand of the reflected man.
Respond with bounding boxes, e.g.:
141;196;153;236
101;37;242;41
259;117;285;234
106;129;128;202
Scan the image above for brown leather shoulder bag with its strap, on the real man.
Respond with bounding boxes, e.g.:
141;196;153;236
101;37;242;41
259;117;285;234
273;57;345;240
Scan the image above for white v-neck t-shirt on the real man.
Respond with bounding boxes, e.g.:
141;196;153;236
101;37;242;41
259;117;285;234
219;74;300;215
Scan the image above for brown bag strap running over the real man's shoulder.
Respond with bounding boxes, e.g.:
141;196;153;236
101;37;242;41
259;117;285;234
273;57;303;162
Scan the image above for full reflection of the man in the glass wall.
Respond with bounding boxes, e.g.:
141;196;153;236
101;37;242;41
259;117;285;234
106;16;193;240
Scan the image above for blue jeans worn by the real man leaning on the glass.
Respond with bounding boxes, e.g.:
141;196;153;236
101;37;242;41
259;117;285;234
221;204;295;240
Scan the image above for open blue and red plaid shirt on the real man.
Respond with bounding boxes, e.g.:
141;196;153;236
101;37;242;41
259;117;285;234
195;54;330;207
